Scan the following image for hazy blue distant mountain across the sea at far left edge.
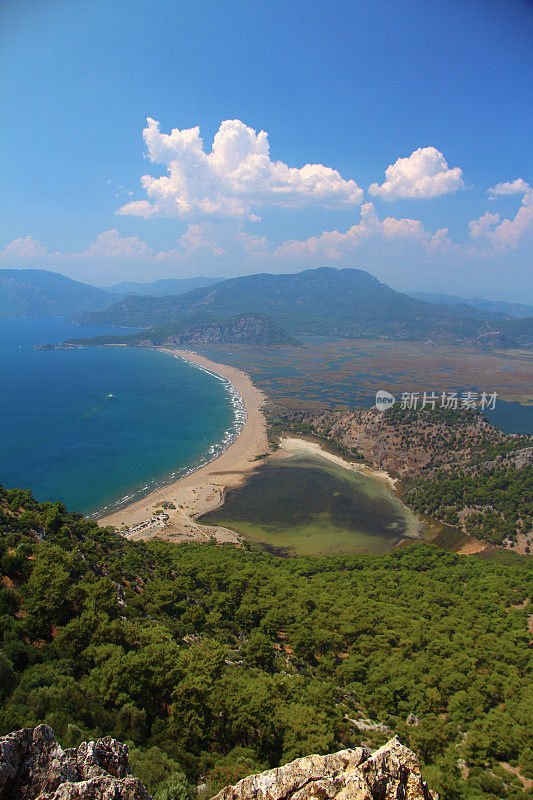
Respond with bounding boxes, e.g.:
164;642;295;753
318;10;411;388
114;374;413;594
0;269;117;317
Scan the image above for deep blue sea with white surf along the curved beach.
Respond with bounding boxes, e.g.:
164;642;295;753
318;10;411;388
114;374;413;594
0;319;243;514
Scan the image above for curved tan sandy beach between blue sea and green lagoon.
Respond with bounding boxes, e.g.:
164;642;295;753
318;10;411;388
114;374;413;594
98;348;269;544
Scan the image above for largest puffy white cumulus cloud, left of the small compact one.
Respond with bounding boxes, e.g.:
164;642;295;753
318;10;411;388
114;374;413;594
118;117;363;221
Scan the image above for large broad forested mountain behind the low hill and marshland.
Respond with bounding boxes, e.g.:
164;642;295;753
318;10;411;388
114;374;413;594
79;268;531;346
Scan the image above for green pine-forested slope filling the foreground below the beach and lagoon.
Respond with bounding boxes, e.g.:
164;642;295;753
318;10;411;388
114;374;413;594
0;490;533;800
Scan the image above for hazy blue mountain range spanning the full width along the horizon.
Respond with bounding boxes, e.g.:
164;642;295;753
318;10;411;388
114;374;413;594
0;267;533;348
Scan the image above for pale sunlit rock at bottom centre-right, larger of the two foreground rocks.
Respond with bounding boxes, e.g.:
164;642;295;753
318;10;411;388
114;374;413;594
214;738;438;800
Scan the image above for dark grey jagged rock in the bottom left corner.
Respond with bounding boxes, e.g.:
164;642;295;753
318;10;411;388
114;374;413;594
0;725;151;800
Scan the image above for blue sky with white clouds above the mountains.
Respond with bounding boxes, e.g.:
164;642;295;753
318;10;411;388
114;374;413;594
0;0;533;302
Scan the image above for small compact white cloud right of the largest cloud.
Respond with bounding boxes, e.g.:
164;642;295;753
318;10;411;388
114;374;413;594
368;147;464;200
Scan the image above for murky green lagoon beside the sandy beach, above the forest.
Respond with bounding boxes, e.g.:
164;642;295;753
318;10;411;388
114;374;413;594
200;453;422;556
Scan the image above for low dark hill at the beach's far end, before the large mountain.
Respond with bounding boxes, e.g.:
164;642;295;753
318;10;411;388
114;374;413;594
63;313;298;347
